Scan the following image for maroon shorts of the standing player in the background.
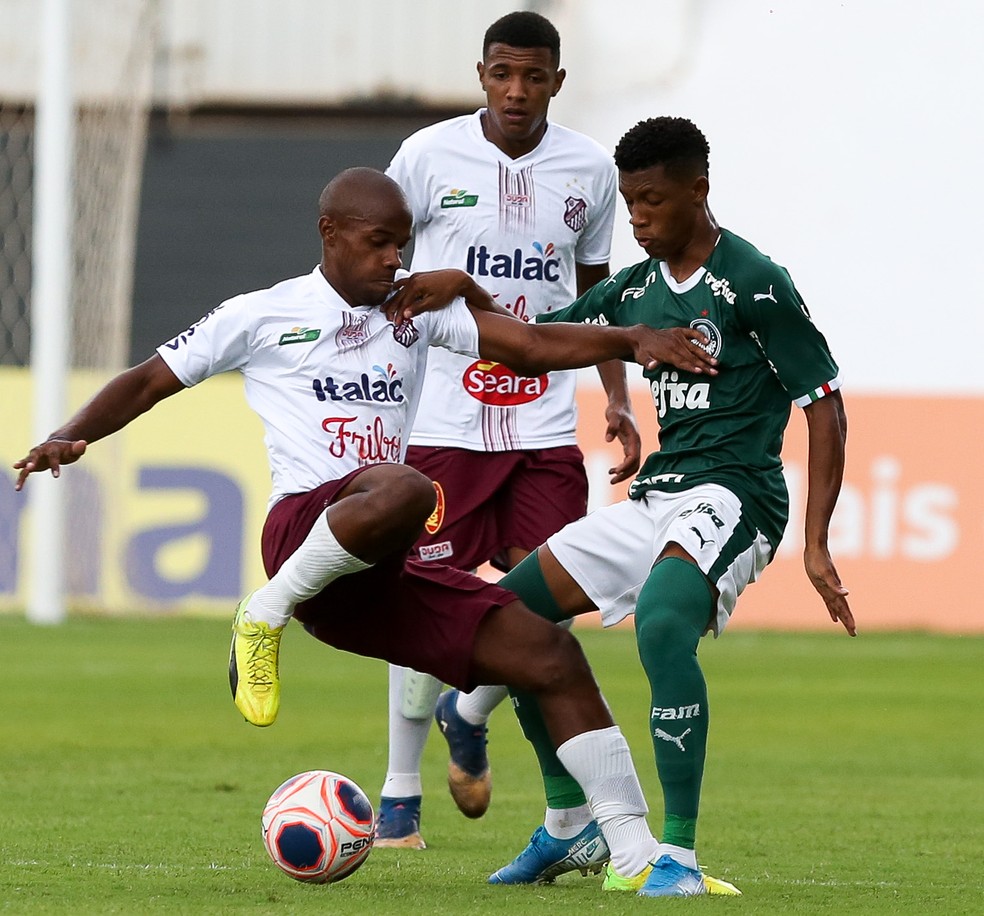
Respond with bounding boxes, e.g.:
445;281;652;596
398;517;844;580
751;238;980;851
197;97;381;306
406;445;588;571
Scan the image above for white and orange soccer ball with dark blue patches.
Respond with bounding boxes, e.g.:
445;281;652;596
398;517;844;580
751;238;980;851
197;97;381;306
262;770;376;884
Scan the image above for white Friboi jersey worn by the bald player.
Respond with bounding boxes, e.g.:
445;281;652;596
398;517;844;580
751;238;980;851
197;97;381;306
157;268;478;506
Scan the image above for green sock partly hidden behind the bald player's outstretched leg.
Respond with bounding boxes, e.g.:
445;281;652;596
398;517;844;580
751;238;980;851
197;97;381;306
499;551;587;809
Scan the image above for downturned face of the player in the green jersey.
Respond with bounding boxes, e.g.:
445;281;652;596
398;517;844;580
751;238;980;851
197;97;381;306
618;165;708;261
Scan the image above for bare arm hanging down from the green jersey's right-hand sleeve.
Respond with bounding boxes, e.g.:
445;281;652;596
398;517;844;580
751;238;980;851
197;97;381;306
803;391;857;636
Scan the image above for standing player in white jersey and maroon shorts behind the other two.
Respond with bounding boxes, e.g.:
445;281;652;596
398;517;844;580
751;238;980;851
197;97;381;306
376;12;641;849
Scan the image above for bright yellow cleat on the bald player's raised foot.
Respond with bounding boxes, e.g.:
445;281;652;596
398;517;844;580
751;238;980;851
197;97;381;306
229;595;284;728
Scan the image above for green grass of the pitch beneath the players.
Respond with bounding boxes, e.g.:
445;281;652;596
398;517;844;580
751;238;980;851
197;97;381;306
0;617;984;916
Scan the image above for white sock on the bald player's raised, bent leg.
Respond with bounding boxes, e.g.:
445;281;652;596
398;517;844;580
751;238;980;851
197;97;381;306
246;515;372;627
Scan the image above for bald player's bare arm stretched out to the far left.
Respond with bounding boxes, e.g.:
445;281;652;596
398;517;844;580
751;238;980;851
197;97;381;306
14;354;184;490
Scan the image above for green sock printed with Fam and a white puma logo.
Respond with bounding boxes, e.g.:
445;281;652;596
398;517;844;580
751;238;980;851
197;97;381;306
635;557;714;849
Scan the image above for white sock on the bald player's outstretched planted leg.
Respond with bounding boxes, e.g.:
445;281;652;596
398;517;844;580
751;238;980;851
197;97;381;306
557;725;659;878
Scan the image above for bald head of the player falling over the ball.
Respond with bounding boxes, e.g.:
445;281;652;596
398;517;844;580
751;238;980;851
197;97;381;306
318;168;413;306
